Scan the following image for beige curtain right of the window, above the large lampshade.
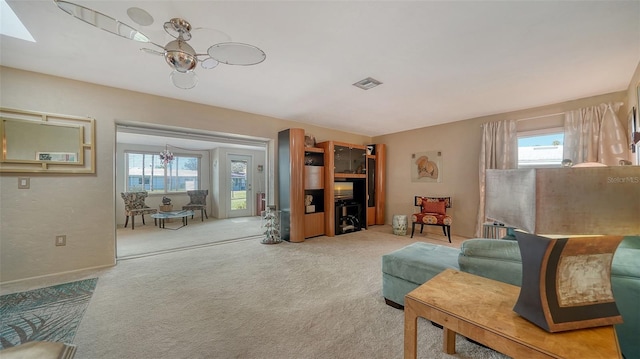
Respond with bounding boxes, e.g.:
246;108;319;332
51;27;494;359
563;103;629;166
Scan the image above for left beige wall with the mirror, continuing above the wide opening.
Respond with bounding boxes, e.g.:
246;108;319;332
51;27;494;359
0;67;370;282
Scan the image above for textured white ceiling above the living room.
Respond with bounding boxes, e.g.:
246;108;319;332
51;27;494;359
0;0;640;136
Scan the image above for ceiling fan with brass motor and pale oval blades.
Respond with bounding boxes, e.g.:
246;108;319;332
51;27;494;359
54;0;267;89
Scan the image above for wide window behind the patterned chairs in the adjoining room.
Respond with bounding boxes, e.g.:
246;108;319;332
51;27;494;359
124;152;201;194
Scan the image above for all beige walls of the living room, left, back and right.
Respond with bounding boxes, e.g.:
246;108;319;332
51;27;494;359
0;63;640;282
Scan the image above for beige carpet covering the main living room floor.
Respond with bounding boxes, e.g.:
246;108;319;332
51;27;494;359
3;225;505;359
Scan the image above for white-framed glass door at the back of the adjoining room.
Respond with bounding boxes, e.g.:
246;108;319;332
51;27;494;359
227;154;254;218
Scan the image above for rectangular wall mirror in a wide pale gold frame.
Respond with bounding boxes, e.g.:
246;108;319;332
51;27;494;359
0;108;95;173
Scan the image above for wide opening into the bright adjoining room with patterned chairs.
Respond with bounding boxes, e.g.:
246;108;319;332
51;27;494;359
114;124;274;259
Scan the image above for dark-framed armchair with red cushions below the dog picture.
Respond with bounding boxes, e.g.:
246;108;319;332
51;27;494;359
411;196;453;243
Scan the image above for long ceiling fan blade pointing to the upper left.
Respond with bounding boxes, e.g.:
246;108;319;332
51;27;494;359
55;0;151;45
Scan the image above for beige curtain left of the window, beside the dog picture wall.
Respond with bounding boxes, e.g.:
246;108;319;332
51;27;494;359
476;120;518;237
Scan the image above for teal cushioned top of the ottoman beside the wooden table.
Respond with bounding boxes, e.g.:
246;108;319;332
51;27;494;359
382;242;460;284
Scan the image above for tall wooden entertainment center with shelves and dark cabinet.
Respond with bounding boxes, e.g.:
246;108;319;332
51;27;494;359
278;128;386;242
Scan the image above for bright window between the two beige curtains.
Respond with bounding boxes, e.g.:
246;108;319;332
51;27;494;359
518;128;564;168
